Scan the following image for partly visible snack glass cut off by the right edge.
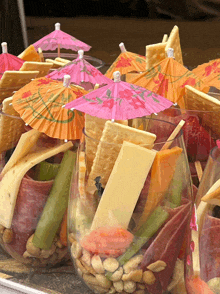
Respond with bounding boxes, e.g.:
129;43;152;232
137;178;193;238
186;146;220;294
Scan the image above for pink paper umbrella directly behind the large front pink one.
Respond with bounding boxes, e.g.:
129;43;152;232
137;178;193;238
47;50;113;91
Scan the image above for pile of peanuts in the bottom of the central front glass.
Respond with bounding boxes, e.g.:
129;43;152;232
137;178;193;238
71;234;167;294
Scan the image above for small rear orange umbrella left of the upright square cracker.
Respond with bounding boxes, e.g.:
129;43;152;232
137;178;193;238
105;43;146;79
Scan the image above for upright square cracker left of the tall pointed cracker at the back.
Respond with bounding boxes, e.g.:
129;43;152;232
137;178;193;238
146;42;167;70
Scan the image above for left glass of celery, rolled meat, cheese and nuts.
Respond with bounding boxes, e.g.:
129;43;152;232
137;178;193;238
0;107;77;267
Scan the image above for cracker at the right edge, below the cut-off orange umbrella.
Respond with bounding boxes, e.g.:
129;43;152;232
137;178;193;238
184;85;220;137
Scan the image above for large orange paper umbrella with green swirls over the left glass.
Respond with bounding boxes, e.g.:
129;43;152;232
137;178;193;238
12;75;88;140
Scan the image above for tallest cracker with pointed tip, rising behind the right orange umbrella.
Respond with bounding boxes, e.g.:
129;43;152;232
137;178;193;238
165;26;183;64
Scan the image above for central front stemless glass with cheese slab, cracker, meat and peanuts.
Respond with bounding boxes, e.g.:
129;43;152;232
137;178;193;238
68;118;193;294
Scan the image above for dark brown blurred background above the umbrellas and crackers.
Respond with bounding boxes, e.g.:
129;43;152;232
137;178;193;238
0;0;220;67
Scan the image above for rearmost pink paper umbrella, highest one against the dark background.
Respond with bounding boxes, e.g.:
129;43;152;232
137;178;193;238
33;23;91;57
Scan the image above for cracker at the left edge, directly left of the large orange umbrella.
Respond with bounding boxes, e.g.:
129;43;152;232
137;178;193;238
0;97;25;153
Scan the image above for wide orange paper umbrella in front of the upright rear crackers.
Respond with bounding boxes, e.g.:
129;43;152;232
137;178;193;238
130;49;209;108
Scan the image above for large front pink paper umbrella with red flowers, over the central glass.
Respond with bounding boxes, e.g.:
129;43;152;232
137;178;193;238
64;71;173;120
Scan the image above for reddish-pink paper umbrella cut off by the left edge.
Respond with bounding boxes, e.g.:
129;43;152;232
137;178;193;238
0;42;24;79
